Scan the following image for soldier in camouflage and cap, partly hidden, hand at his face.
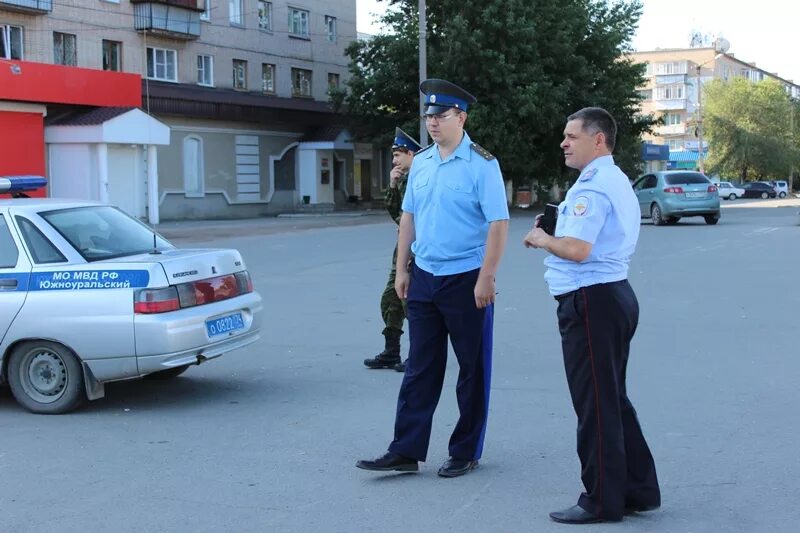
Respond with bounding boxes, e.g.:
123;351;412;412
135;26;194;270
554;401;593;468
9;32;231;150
364;128;421;372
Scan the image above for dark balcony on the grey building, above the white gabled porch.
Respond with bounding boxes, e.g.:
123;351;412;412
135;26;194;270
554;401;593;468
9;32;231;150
131;0;206;40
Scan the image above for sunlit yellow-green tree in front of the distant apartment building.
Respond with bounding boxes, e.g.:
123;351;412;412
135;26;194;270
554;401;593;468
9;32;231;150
703;77;800;181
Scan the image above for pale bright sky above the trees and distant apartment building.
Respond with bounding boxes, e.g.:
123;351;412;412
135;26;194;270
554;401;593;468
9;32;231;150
356;0;800;85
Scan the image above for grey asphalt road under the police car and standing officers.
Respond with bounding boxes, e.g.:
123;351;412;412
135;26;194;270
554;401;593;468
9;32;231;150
0;200;800;533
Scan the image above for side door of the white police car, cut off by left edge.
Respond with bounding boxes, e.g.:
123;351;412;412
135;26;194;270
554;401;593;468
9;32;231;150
0;211;31;342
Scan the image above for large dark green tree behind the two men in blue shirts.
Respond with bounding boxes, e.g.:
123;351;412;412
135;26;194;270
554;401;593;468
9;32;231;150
335;0;653;189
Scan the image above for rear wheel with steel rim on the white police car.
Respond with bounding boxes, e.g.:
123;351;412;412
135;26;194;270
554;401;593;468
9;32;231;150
8;340;86;414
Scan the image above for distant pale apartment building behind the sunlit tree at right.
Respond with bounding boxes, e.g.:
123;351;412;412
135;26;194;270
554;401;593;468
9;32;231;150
631;47;800;169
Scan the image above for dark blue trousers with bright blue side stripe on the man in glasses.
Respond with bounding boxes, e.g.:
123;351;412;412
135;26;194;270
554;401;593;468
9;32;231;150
389;265;494;461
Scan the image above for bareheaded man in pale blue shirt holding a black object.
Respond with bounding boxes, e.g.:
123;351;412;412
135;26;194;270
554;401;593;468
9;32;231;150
523;107;661;524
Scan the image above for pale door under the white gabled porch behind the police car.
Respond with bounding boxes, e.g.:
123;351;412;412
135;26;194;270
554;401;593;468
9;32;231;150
108;144;145;218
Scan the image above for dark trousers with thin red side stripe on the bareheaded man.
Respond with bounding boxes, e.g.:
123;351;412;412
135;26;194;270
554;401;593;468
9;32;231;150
556;280;661;520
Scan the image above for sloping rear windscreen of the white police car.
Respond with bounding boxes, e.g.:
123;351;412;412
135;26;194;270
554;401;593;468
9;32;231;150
39;206;172;262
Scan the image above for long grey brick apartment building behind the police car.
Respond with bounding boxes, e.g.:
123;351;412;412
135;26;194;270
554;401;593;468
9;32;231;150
0;0;360;220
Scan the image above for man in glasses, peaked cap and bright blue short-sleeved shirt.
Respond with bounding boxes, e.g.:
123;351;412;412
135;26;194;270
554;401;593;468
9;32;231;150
356;79;508;477
